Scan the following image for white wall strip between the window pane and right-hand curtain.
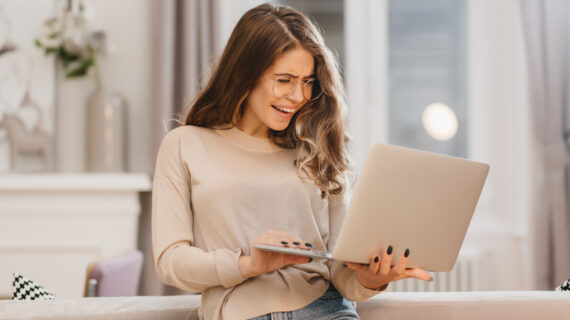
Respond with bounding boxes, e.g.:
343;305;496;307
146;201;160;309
466;0;534;290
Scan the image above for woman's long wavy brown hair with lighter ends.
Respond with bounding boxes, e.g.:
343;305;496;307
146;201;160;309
182;4;350;199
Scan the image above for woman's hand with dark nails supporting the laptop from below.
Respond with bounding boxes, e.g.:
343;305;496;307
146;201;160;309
345;246;432;290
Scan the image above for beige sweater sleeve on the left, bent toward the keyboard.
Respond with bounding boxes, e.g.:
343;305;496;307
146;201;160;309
152;130;245;292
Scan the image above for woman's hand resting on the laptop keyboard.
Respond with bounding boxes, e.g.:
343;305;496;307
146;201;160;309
239;230;313;279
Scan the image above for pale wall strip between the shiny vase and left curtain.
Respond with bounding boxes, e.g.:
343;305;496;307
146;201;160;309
89;0;155;172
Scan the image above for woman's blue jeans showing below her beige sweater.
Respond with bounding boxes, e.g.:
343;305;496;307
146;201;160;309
247;284;360;320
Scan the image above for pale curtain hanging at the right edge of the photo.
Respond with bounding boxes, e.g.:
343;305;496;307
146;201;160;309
521;0;570;290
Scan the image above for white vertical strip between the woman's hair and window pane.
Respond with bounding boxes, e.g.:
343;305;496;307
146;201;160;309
344;0;390;166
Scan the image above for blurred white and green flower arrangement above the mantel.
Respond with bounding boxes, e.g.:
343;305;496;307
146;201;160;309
35;0;105;83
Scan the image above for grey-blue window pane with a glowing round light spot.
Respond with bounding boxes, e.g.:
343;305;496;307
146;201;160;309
388;0;468;157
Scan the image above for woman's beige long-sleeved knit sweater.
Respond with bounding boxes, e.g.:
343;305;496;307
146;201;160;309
152;126;378;319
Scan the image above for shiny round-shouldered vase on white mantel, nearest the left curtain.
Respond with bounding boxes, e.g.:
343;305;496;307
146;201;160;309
85;87;127;172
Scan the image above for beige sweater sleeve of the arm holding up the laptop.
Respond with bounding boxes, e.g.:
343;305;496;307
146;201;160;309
327;195;380;301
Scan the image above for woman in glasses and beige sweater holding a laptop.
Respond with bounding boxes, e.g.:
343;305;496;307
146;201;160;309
152;4;430;319
